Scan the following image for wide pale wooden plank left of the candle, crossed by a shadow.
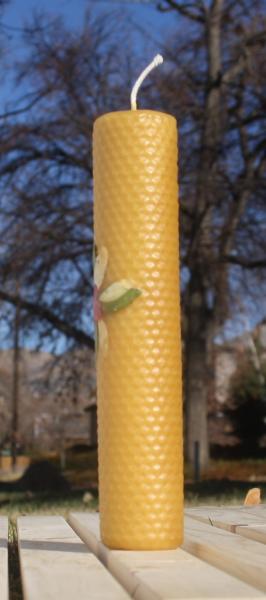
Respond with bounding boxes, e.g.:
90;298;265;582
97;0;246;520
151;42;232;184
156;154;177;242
18;516;128;600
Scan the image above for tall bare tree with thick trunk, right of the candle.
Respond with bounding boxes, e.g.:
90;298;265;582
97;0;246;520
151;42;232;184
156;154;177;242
156;0;266;467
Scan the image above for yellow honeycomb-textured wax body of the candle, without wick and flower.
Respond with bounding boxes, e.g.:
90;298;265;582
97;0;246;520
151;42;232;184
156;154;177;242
93;110;183;550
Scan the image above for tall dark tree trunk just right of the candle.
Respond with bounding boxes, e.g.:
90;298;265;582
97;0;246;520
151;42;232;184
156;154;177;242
185;0;224;470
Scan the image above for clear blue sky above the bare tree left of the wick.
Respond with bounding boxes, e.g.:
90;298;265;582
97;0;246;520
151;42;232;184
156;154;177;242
0;0;177;107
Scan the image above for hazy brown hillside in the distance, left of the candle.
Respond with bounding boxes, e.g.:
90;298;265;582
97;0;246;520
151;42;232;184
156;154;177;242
0;349;95;449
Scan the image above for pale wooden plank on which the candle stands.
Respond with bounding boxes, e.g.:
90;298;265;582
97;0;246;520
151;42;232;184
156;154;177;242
69;513;265;600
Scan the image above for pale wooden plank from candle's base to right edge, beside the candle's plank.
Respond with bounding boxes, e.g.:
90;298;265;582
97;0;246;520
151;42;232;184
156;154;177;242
183;517;266;592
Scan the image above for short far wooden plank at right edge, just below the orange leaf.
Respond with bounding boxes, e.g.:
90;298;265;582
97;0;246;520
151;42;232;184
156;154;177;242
185;507;266;533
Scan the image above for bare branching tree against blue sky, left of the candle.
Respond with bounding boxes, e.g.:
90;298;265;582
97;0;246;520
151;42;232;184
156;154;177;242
0;10;134;348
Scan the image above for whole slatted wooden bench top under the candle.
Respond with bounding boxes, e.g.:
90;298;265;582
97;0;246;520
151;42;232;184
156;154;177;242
0;505;266;600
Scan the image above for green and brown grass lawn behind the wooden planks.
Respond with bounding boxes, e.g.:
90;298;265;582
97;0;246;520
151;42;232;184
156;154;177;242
0;451;266;519
